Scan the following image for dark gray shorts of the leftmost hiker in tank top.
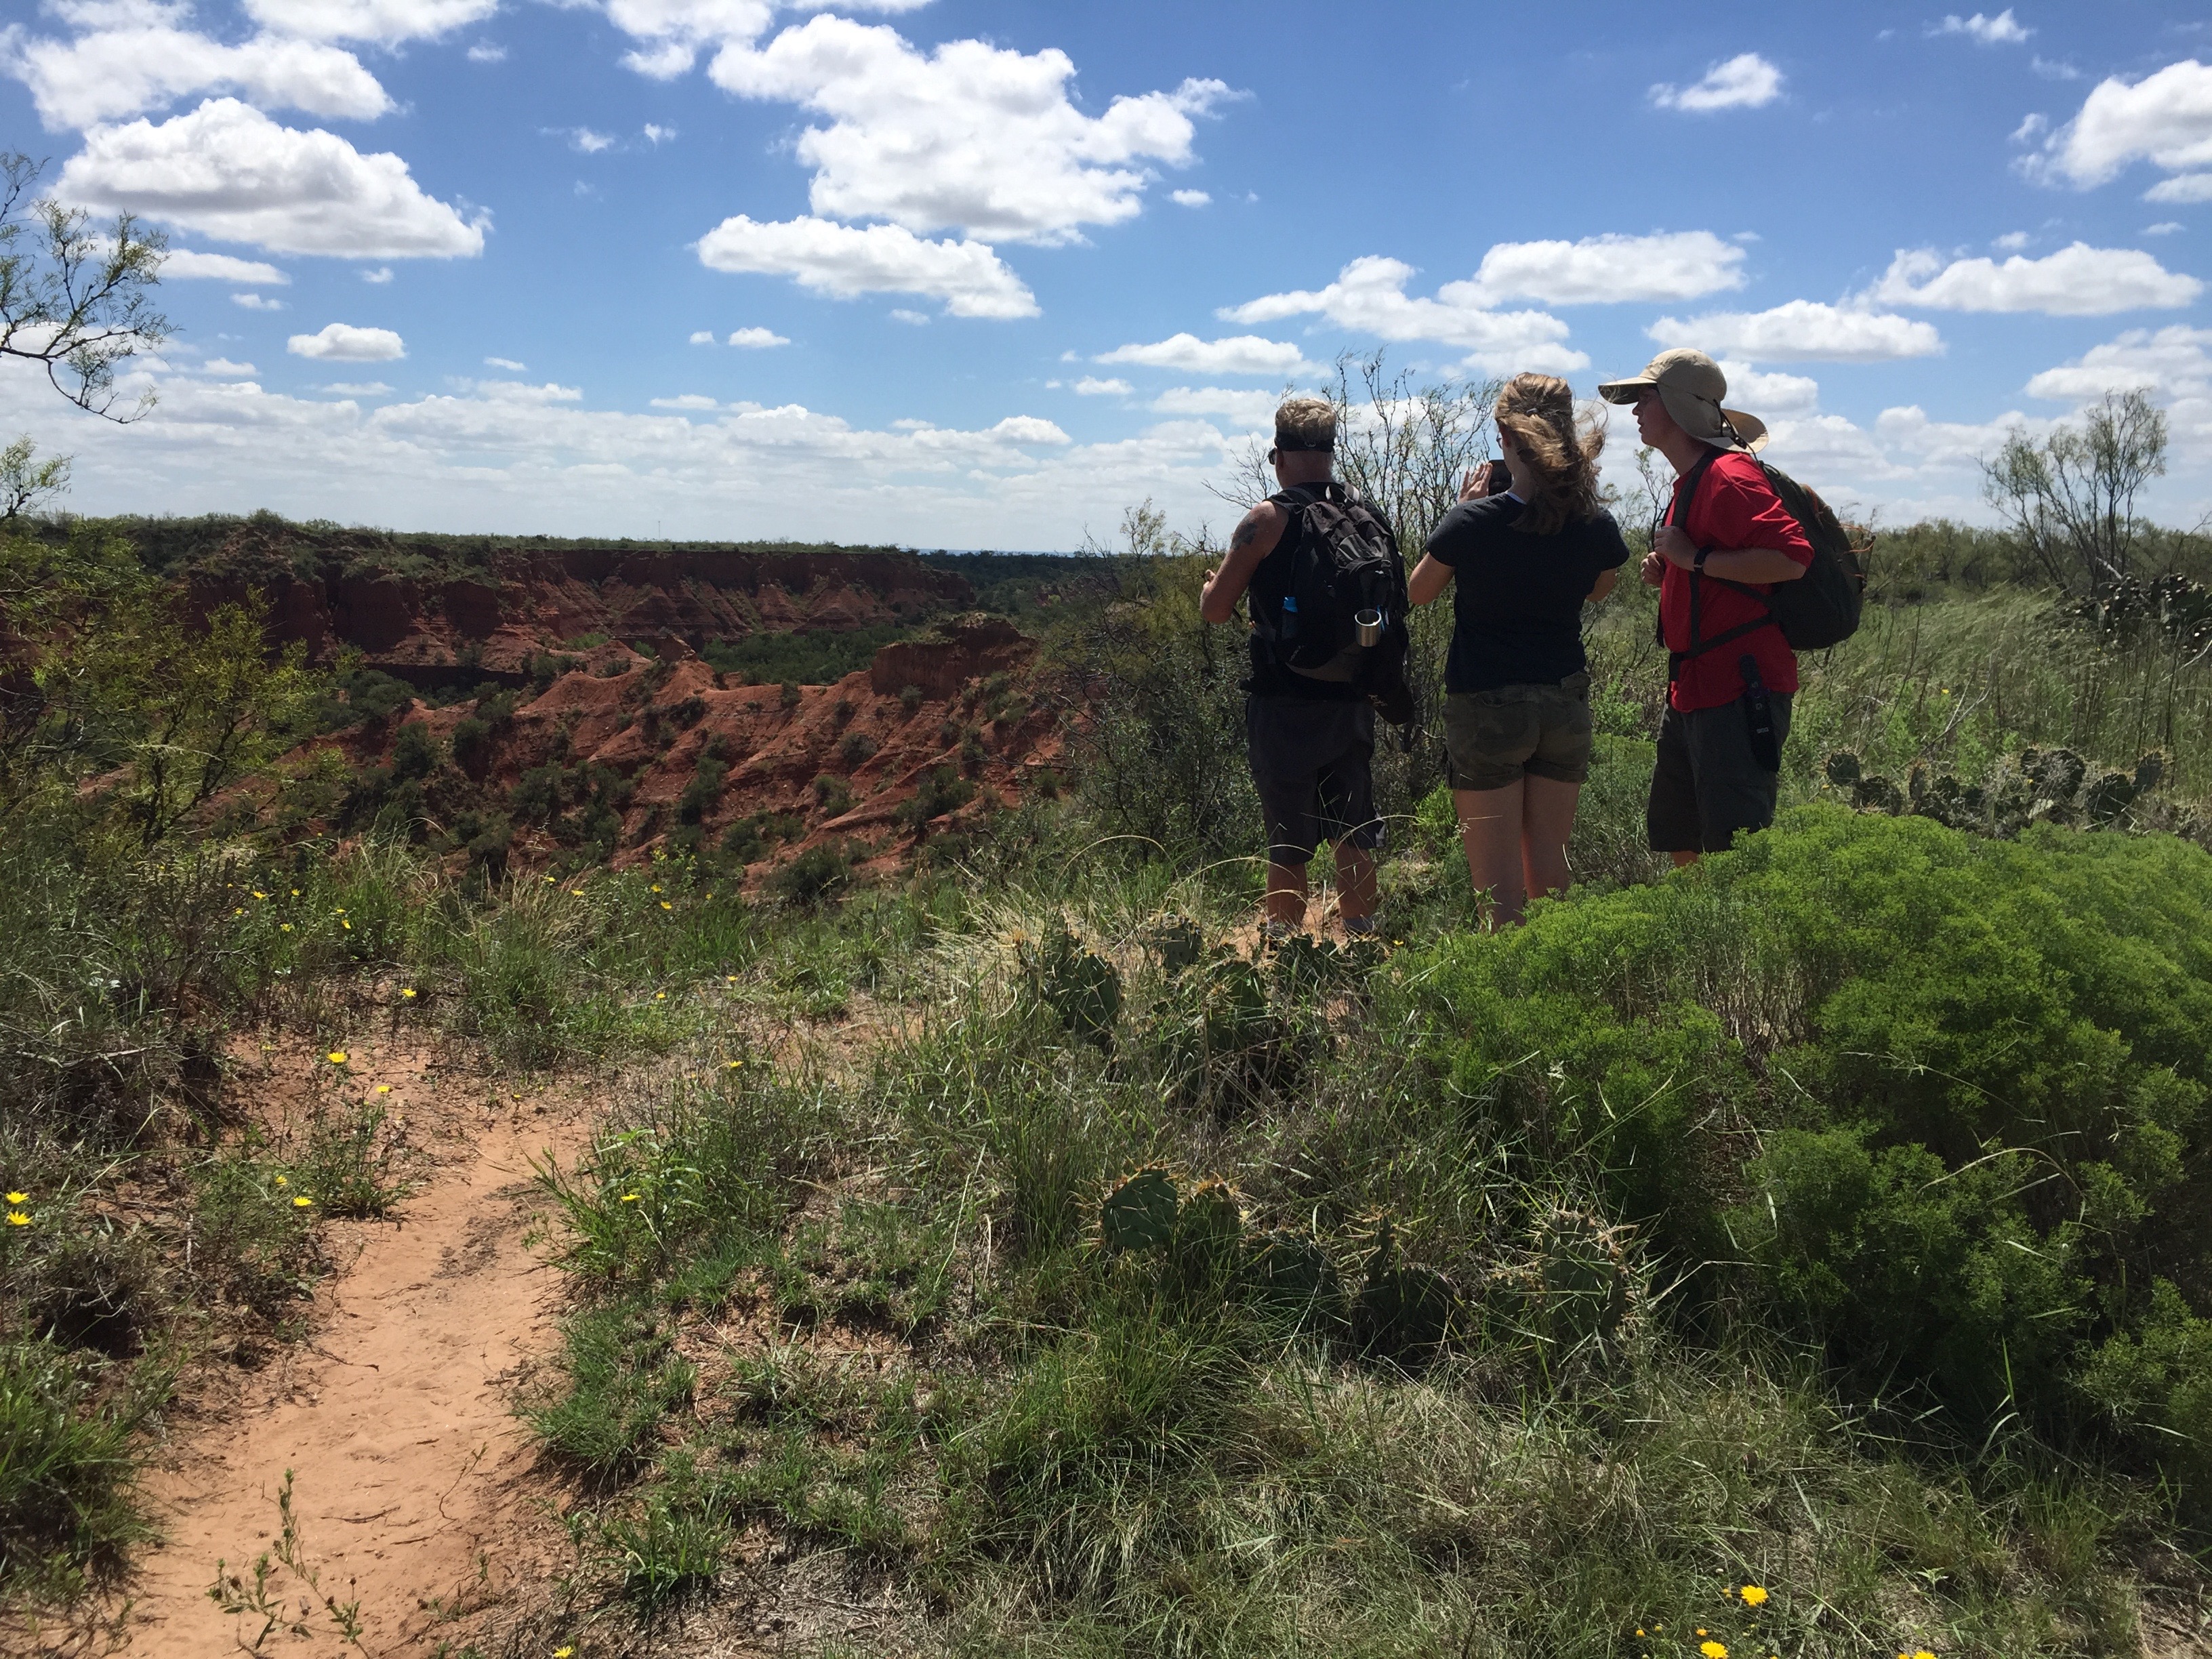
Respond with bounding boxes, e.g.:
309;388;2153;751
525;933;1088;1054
1246;697;1382;865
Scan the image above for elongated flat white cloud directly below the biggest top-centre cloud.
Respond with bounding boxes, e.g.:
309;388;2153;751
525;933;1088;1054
699;215;1038;316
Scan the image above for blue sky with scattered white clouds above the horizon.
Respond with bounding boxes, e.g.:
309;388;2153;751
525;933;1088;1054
0;0;2212;548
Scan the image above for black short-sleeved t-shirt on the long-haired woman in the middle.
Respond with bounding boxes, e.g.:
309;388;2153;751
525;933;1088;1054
1427;495;1628;690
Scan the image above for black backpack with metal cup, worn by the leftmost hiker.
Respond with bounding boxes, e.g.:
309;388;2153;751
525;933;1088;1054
1252;480;1414;726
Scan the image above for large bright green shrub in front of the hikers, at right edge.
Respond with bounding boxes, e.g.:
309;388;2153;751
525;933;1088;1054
1416;807;2212;1477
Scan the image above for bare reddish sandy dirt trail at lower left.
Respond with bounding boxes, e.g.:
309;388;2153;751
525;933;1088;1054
126;1106;584;1659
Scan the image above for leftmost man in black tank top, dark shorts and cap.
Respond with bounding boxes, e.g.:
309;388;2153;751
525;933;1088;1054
1199;398;1382;936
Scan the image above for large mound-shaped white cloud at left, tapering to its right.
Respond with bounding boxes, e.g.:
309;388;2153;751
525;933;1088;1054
56;98;485;259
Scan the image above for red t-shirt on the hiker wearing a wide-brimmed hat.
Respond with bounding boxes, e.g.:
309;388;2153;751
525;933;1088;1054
1659;449;1811;712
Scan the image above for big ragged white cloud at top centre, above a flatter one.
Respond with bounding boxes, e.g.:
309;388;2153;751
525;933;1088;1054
708;16;1228;245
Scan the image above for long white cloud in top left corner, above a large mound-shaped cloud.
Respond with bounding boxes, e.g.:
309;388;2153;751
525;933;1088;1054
0;14;392;128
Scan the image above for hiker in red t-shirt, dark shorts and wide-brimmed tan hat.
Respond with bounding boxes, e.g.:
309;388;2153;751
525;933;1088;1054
1597;350;1811;865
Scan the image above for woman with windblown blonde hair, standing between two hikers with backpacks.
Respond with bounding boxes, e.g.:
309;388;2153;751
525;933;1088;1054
1407;374;1628;927
